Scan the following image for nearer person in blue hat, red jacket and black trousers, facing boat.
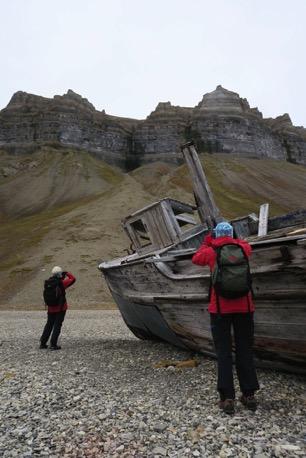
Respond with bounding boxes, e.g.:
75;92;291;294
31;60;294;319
192;222;259;414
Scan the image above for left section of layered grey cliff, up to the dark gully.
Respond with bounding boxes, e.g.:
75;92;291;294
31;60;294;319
0;90;133;168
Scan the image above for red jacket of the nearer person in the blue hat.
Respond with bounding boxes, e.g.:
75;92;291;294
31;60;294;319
192;234;255;313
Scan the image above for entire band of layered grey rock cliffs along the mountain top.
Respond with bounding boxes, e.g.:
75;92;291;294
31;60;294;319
0;86;306;170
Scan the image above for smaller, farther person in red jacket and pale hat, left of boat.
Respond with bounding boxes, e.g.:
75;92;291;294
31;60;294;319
39;266;75;350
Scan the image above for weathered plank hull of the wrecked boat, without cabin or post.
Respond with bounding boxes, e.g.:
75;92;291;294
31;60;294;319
101;238;306;374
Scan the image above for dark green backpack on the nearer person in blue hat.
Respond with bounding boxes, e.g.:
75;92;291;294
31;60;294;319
211;243;252;299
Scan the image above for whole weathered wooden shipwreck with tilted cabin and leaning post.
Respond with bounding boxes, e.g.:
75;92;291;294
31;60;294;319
99;142;306;374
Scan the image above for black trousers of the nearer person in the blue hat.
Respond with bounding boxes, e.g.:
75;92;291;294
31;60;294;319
210;313;259;401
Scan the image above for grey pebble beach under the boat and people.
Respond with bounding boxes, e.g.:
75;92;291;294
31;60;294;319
0;310;306;458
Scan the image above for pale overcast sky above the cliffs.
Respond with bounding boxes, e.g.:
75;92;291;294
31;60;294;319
0;0;306;126
